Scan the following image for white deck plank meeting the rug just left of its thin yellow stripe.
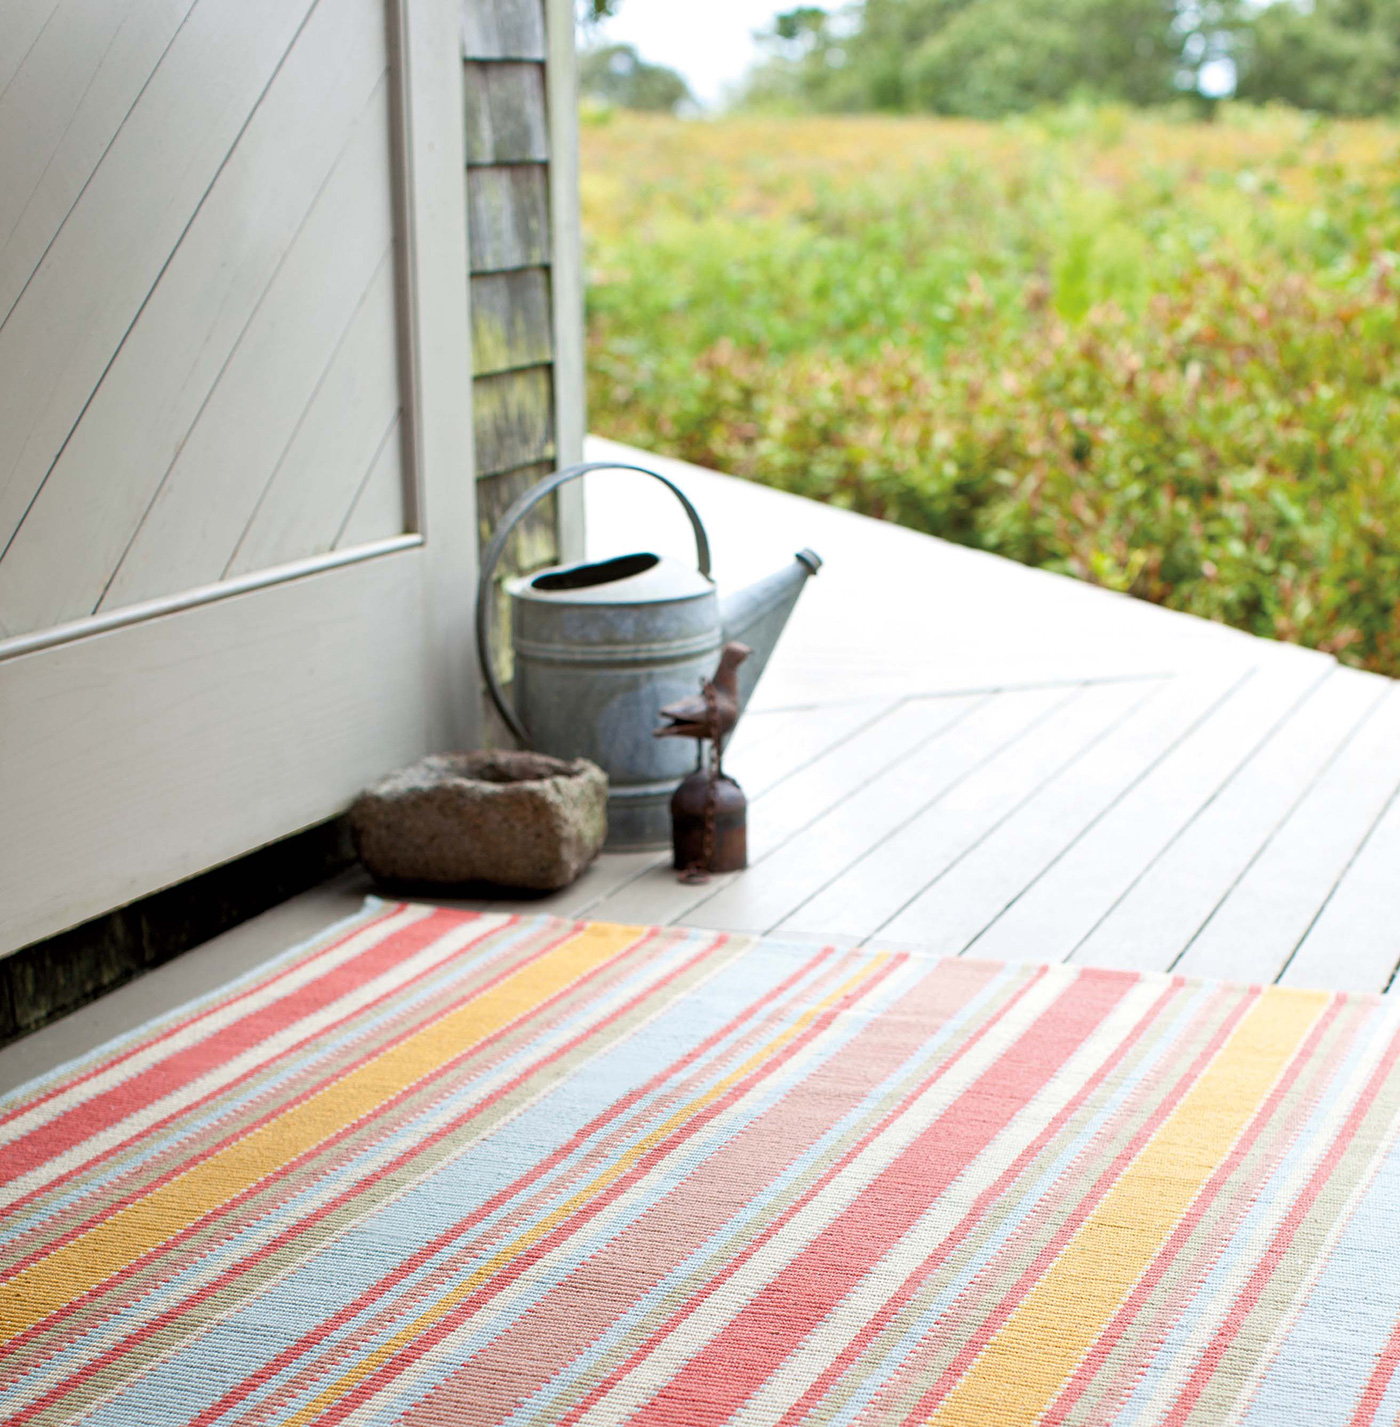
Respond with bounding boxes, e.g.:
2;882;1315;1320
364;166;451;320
778;681;1157;936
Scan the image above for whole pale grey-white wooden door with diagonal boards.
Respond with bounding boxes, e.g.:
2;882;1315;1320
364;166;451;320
0;0;480;953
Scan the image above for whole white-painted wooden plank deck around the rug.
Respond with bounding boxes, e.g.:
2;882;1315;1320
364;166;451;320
0;441;1400;1087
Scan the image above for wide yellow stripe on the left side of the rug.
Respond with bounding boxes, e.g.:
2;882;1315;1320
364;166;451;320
0;923;646;1341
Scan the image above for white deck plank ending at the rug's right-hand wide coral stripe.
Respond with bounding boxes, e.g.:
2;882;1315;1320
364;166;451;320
1073;669;1379;970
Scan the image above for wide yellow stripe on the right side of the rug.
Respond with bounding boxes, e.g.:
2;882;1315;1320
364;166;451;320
929;989;1330;1427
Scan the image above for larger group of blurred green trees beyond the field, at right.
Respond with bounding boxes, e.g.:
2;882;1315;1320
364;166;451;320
749;0;1400;118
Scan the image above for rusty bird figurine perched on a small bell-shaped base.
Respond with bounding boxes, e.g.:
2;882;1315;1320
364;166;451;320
654;641;752;882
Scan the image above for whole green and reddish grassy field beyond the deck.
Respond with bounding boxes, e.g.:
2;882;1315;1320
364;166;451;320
584;108;1400;675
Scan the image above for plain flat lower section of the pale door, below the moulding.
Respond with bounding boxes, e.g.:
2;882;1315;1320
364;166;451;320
0;548;428;949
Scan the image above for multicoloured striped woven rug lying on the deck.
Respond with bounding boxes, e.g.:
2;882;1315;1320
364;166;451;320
0;902;1400;1427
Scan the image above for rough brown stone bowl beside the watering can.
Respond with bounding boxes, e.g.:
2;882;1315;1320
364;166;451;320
350;751;608;892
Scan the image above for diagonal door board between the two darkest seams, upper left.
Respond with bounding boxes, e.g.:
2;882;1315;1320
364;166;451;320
0;0;319;562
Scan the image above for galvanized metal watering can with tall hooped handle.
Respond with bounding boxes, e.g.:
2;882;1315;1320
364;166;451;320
477;461;822;848
